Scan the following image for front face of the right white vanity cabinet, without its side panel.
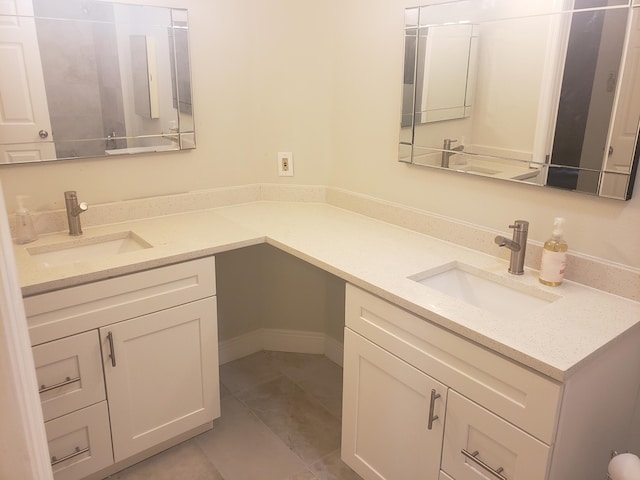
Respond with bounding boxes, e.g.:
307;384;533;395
342;285;562;480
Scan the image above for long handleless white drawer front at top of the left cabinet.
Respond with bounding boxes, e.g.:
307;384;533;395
24;257;216;345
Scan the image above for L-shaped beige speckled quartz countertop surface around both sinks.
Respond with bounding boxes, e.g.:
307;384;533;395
15;201;640;381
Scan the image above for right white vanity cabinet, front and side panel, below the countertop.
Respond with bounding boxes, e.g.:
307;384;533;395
342;285;640;480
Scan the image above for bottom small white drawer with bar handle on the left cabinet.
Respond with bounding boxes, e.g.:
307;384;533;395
44;402;113;480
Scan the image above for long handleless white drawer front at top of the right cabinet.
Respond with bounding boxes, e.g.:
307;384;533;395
345;285;561;444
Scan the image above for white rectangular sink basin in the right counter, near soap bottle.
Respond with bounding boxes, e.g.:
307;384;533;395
409;262;560;318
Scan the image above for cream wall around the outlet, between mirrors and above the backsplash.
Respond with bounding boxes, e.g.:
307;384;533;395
0;0;640;268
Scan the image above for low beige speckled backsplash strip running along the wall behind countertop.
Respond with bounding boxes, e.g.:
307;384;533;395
10;184;640;301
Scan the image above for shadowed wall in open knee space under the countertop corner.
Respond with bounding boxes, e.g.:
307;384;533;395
216;244;344;343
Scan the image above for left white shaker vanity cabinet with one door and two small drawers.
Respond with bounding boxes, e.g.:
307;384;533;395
24;257;220;480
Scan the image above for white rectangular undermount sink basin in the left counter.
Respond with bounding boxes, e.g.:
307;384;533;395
27;231;152;267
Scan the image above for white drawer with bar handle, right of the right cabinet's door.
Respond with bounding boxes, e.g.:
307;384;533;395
442;391;550;480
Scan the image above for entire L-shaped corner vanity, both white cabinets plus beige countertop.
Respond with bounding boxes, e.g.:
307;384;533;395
16;196;640;480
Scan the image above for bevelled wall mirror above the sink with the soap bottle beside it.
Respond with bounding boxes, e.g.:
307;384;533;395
399;0;640;200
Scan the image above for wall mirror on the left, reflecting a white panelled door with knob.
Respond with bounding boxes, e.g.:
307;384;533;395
0;0;195;164
